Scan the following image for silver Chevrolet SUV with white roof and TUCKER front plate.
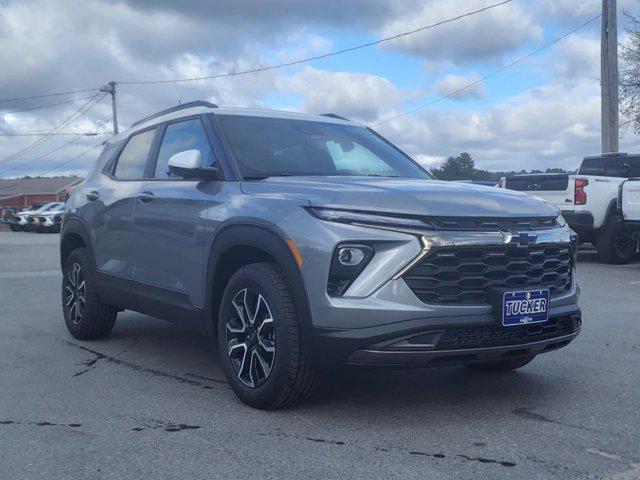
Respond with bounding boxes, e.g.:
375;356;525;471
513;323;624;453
60;102;581;409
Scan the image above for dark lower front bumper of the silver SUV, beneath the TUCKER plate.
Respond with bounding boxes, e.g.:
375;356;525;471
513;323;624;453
313;306;582;367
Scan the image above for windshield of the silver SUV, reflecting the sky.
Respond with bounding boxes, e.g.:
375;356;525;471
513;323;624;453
217;115;431;179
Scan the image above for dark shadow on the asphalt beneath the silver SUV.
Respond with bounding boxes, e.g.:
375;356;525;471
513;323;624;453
102;312;575;415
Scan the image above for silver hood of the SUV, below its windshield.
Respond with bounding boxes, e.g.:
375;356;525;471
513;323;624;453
242;176;558;217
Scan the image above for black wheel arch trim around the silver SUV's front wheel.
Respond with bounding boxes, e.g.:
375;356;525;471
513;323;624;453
204;218;312;339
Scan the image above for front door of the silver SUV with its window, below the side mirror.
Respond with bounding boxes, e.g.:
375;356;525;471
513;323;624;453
133;117;221;319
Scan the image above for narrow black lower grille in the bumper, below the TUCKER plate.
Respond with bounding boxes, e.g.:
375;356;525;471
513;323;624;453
436;316;581;350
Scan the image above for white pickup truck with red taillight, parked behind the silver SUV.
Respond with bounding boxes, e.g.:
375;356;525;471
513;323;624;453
499;153;640;264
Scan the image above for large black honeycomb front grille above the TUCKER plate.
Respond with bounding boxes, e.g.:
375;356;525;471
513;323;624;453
403;244;573;304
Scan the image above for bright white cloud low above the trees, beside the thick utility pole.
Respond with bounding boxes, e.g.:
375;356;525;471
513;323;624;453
380;80;629;174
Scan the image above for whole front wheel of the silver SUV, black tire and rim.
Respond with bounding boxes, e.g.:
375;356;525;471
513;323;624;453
217;263;317;410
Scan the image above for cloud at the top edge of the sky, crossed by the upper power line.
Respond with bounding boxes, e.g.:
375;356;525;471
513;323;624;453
382;0;542;65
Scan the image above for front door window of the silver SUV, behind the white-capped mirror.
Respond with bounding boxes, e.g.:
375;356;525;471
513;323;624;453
153;118;213;178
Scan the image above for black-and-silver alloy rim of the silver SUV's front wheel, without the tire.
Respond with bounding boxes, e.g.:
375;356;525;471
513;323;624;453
226;288;276;388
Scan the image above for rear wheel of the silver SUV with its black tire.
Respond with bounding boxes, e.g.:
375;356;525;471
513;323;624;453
62;248;118;340
